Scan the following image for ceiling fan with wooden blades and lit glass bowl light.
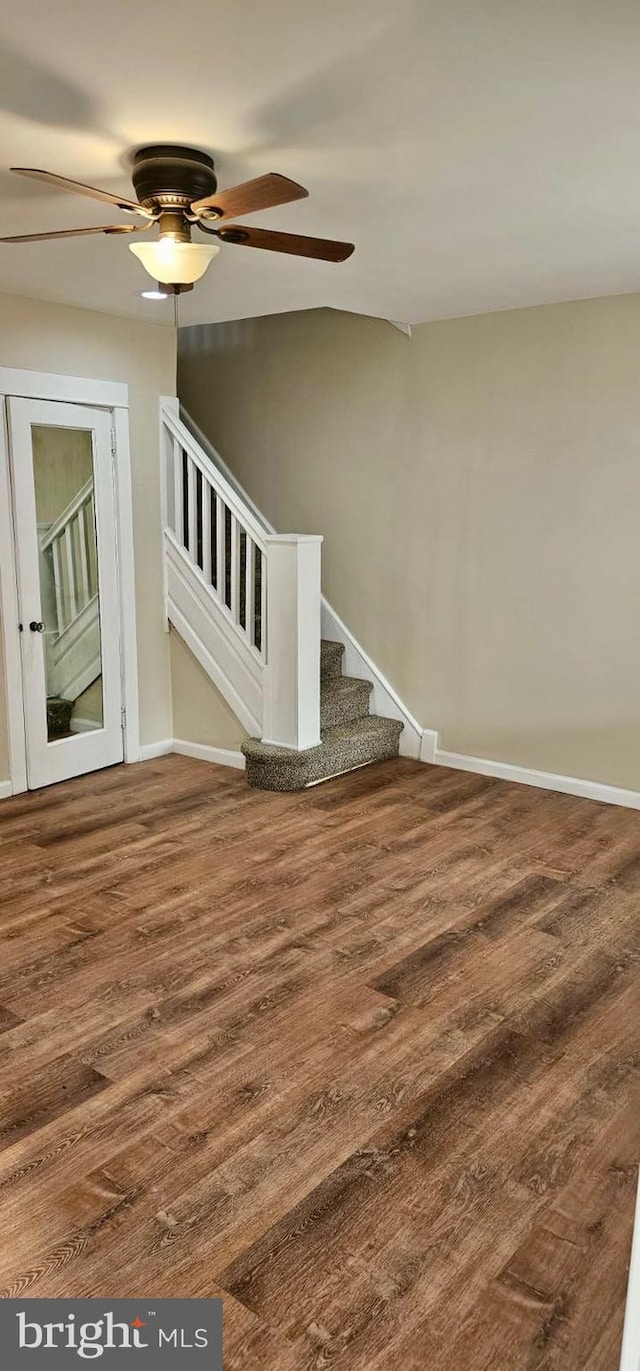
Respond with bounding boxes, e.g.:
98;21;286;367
0;144;354;295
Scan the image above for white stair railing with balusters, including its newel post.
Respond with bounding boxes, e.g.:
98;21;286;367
160;400;322;750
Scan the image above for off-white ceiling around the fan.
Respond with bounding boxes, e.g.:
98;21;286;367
0;0;640;324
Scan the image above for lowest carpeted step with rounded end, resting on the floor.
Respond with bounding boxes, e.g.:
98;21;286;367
243;714;403;790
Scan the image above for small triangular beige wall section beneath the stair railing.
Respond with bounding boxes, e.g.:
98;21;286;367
170;629;247;751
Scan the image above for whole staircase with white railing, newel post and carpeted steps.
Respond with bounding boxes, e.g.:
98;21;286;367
160;402;404;791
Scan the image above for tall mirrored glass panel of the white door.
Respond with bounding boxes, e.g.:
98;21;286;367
32;424;104;743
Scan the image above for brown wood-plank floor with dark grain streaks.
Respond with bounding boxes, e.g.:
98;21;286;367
0;757;640;1371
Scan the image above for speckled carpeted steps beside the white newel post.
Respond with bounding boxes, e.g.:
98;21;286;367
243;638;403;790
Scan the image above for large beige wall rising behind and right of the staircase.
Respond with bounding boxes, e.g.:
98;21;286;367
178;295;640;790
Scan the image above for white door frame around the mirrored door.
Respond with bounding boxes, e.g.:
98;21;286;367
0;366;140;795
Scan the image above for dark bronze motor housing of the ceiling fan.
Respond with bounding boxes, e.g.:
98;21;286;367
132;143;218;210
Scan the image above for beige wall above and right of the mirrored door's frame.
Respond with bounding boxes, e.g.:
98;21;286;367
0;295;175;779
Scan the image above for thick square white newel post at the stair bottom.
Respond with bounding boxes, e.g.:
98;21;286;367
262;533;322;751
